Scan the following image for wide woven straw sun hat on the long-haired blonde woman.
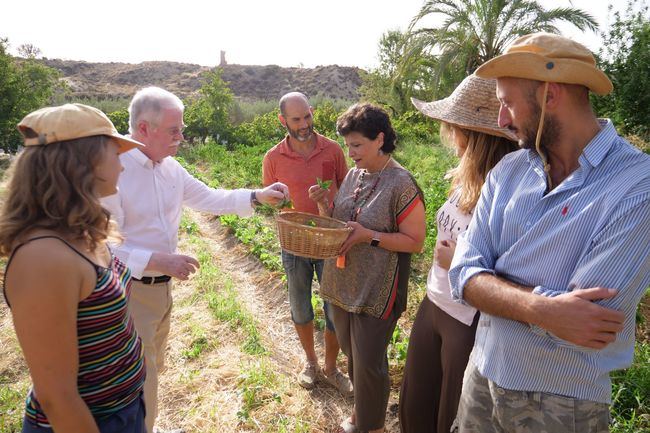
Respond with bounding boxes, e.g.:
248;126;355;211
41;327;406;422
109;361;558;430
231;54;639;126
411;74;517;141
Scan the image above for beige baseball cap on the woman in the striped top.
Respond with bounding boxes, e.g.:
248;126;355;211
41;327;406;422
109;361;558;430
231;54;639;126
18;104;144;153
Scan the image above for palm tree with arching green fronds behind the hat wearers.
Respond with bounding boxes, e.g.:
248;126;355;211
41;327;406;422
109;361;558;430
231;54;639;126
364;0;598;112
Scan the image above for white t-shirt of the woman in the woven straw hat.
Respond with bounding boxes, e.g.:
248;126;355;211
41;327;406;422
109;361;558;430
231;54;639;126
427;191;476;326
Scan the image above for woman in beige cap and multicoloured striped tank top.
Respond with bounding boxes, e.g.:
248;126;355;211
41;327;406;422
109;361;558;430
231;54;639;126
0;104;144;433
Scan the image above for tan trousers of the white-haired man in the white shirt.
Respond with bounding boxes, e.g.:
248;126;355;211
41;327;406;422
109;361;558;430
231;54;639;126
129;280;172;433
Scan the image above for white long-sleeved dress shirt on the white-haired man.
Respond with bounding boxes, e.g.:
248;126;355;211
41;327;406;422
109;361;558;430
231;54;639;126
102;149;253;278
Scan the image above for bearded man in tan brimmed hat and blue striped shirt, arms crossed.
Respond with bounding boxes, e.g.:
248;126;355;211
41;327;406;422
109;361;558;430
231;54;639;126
449;33;650;432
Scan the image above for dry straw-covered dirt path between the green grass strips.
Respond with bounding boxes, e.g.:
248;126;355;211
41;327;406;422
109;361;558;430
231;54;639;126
155;211;370;432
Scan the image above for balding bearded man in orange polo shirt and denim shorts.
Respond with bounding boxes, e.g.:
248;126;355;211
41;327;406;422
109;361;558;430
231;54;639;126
262;92;352;396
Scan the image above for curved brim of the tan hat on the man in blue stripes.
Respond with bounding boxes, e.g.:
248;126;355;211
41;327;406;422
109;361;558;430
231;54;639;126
475;52;613;95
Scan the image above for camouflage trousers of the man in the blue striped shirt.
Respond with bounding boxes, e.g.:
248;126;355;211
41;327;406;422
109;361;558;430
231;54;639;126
452;362;609;433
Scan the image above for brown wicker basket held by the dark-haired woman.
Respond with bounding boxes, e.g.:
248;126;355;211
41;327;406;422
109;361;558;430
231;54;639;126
275;211;352;259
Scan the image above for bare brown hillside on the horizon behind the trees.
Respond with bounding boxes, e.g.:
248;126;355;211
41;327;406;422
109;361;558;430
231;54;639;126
43;59;361;100
